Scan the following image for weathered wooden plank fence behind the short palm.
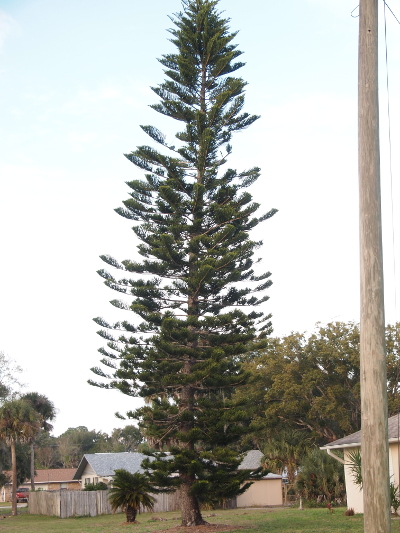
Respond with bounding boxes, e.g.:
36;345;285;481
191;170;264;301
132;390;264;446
29;490;180;518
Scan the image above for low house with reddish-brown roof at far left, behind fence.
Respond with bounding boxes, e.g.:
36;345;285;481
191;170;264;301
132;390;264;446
0;468;81;502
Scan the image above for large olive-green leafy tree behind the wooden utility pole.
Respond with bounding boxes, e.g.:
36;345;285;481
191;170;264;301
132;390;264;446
237;322;400;449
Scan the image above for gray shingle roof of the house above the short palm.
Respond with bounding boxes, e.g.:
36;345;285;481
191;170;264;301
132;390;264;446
74;452;151;479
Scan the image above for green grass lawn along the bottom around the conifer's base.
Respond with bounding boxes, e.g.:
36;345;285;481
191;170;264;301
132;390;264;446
0;508;400;533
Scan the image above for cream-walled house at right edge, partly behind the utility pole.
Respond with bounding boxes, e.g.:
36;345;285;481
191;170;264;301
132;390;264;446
321;415;400;513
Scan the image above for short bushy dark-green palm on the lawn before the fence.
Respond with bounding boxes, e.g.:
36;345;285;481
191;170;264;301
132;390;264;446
109;469;156;522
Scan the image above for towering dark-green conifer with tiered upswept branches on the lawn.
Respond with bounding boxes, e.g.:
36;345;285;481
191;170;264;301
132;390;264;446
91;0;275;526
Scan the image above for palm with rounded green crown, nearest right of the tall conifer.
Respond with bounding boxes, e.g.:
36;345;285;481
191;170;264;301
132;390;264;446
264;428;310;484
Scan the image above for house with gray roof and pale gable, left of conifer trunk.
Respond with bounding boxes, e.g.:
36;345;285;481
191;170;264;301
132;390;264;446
73;452;152;488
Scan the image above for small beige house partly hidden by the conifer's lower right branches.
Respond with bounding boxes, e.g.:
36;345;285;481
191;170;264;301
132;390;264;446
236;450;283;507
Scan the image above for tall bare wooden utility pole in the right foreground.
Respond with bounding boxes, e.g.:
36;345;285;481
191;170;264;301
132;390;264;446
358;0;391;533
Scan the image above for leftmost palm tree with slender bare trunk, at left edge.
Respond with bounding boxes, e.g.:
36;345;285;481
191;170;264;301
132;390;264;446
0;399;42;516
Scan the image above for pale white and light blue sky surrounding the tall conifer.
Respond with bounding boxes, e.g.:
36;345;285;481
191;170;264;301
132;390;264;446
0;0;400;435
